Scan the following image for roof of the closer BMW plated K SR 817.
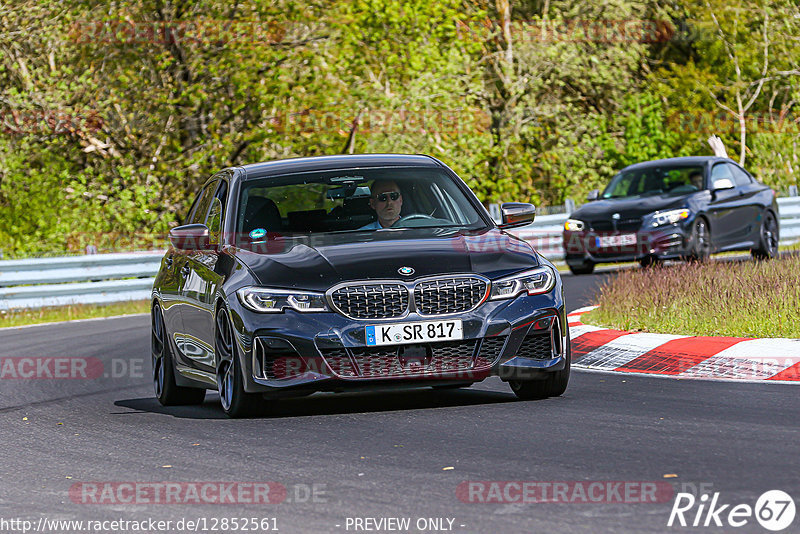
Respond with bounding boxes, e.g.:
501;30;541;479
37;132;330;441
236;154;444;180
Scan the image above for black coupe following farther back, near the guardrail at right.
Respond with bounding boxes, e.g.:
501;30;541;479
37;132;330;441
564;156;779;274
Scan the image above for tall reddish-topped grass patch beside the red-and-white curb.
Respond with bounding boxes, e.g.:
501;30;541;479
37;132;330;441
582;255;800;338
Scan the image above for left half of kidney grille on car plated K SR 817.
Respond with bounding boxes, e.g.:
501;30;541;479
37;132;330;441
331;283;408;319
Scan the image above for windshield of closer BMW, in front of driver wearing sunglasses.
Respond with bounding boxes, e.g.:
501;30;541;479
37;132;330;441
237;167;487;236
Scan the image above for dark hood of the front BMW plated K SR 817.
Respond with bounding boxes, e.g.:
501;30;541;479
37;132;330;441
236;229;539;291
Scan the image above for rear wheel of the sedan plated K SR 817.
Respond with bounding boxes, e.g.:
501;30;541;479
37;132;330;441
150;305;206;406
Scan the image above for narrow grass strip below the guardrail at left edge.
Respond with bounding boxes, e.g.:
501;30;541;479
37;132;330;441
0;300;150;328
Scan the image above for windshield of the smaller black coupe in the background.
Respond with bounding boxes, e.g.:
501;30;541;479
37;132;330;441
600;165;703;198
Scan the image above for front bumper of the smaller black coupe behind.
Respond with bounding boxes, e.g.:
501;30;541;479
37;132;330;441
564;223;693;265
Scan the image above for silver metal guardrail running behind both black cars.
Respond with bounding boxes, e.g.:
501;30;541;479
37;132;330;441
0;197;800;310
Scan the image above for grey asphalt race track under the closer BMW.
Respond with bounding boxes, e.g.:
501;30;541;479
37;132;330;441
0;273;800;533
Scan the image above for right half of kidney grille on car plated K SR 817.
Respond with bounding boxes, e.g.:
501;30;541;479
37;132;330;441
414;278;487;315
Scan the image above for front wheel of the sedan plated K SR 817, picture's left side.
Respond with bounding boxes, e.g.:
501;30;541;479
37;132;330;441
214;309;262;418
